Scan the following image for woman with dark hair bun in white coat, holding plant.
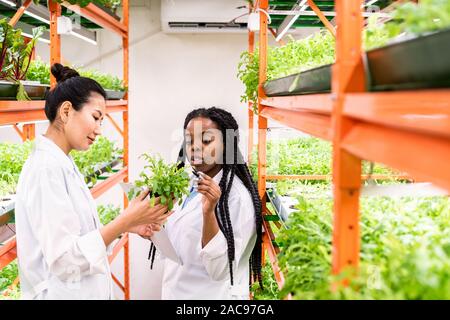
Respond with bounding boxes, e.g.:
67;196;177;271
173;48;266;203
15;64;169;299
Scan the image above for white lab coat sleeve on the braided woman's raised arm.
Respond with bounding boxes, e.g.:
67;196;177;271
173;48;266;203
199;194;255;281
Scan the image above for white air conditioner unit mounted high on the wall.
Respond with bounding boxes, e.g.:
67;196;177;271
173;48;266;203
161;0;248;33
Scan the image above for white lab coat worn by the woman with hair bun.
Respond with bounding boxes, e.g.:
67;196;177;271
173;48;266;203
15;136;113;299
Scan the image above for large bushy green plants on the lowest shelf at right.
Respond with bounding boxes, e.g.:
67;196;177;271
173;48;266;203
277;197;450;299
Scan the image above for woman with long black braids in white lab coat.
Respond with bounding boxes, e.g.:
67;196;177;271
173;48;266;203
158;107;262;299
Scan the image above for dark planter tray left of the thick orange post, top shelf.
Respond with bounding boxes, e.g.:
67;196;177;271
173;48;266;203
264;64;332;97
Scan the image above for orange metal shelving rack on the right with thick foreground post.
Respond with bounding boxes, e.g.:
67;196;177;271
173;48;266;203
248;0;450;294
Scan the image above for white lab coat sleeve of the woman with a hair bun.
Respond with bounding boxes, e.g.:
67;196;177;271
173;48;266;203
27;167;108;281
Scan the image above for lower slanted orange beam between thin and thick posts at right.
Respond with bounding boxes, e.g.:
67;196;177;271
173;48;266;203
260;107;332;140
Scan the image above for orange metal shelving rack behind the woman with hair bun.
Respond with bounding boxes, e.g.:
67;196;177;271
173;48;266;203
0;0;130;300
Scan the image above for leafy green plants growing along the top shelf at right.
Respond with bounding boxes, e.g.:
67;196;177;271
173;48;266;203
237;0;450;111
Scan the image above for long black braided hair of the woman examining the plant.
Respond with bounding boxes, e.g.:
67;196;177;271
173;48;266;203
178;107;262;288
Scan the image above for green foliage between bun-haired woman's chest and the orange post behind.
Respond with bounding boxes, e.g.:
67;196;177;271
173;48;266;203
70;136;123;186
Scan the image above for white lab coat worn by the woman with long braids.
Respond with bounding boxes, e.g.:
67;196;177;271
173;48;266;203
162;171;256;300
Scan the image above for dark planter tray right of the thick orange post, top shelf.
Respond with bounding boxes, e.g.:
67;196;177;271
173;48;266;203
365;29;450;91
